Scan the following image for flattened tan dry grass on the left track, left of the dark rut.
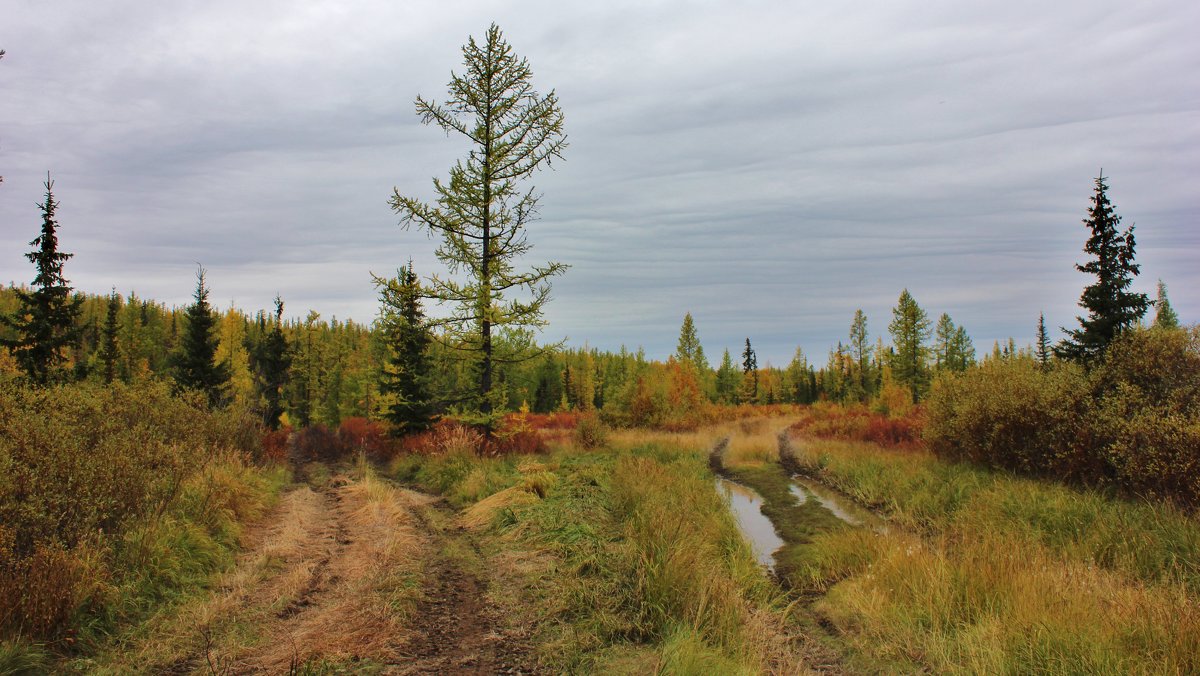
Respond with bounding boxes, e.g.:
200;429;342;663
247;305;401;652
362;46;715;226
94;473;428;672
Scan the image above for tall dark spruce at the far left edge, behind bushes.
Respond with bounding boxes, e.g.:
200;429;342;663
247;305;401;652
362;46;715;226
0;174;83;385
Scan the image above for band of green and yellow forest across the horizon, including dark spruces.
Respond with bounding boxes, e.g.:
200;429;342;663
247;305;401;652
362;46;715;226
0;165;1178;433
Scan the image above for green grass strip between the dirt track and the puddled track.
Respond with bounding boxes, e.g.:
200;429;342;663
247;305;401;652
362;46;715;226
395;443;800;674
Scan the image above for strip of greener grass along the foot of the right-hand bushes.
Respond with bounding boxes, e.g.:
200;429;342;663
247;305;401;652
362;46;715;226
797;441;1200;593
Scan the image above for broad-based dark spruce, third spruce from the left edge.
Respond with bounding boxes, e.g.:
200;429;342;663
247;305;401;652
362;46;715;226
172;268;229;406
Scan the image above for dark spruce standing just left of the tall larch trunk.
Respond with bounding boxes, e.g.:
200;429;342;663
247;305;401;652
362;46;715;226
376;262;436;436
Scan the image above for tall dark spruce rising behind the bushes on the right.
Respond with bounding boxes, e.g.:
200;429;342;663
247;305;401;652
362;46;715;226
1055;172;1150;364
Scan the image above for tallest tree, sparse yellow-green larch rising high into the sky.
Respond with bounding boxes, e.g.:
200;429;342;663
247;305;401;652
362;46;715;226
391;24;566;432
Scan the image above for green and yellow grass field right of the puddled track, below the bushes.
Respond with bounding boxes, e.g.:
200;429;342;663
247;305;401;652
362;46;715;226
794;441;1200;674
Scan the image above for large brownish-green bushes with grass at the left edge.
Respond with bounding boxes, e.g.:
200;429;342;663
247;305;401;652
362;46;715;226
0;383;281;646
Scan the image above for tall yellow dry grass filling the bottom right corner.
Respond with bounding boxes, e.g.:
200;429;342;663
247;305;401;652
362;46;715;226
816;525;1200;674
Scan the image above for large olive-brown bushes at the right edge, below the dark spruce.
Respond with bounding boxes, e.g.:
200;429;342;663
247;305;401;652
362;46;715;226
925;328;1200;507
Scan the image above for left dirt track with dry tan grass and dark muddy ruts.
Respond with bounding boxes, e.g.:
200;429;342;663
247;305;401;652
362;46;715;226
113;473;536;674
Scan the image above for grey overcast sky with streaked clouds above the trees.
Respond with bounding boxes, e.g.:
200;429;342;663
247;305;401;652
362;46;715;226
0;0;1200;365
